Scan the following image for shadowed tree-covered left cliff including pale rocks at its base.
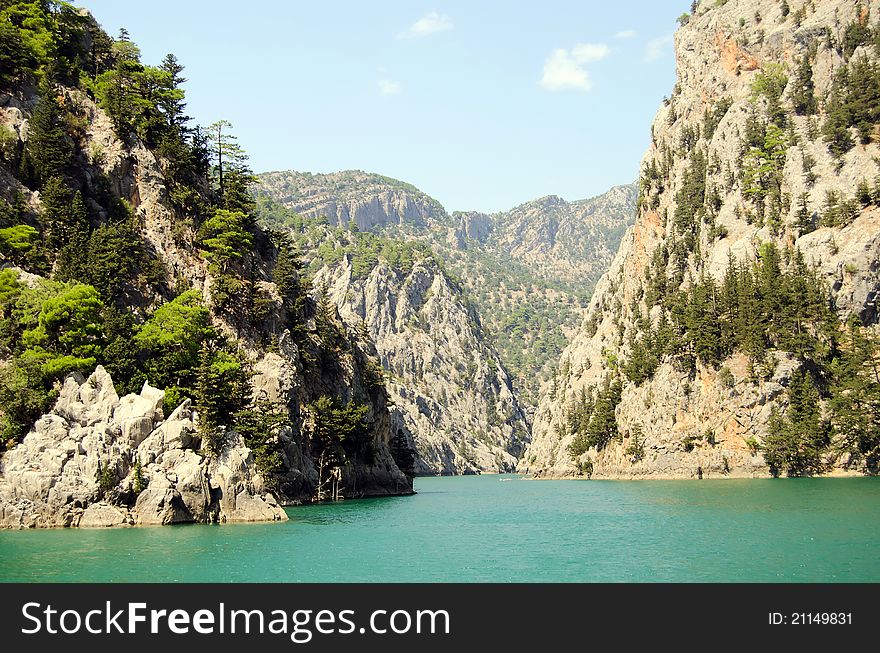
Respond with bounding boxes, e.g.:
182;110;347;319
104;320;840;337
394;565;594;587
0;11;412;527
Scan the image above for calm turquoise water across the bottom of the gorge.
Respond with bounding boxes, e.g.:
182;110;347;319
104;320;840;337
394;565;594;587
0;476;880;582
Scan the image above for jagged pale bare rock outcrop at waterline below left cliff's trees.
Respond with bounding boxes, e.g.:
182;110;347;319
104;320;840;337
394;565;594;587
0;366;287;528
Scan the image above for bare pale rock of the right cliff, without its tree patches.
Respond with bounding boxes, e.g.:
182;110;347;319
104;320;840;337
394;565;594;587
520;0;880;478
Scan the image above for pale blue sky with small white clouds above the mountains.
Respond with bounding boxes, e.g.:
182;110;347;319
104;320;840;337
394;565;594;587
76;0;690;212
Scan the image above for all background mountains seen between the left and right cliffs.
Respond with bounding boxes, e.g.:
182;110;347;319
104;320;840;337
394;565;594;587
256;171;636;474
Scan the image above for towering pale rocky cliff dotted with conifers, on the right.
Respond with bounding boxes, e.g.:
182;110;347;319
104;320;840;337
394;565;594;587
520;0;880;478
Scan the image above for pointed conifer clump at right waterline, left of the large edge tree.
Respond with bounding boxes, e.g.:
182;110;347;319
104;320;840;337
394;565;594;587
762;370;829;476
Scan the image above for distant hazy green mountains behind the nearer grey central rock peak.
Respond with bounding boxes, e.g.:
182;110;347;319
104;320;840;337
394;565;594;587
257;172;637;413
